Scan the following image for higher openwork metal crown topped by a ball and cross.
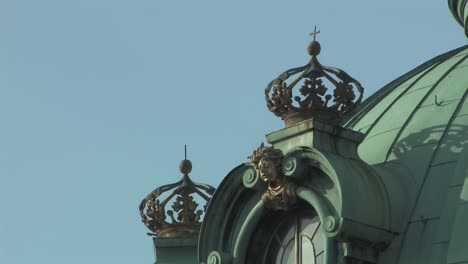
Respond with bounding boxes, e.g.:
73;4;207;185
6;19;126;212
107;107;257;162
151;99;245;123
265;28;364;126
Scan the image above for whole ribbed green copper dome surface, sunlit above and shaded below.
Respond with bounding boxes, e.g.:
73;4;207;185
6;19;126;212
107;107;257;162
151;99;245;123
345;45;468;263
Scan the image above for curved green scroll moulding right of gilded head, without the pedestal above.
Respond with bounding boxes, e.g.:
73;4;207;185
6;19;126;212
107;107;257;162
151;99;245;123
282;148;391;240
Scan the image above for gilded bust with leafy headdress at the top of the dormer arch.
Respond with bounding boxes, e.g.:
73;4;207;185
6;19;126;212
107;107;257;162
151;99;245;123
250;143;296;210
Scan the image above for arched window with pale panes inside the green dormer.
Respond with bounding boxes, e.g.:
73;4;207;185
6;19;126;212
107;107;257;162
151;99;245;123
246;207;325;264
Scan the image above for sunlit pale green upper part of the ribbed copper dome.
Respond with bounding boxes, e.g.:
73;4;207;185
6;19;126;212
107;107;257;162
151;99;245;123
346;46;468;167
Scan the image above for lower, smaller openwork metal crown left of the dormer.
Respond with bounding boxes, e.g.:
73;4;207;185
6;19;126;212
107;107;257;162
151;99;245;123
139;159;215;237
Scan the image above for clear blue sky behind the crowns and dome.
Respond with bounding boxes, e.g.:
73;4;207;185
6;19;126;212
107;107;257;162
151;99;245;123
0;0;467;264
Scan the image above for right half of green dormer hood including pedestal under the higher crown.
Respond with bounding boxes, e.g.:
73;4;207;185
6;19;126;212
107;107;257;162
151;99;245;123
267;120;396;243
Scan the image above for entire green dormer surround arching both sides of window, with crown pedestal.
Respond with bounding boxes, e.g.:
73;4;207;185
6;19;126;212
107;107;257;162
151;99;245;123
199;120;414;264
